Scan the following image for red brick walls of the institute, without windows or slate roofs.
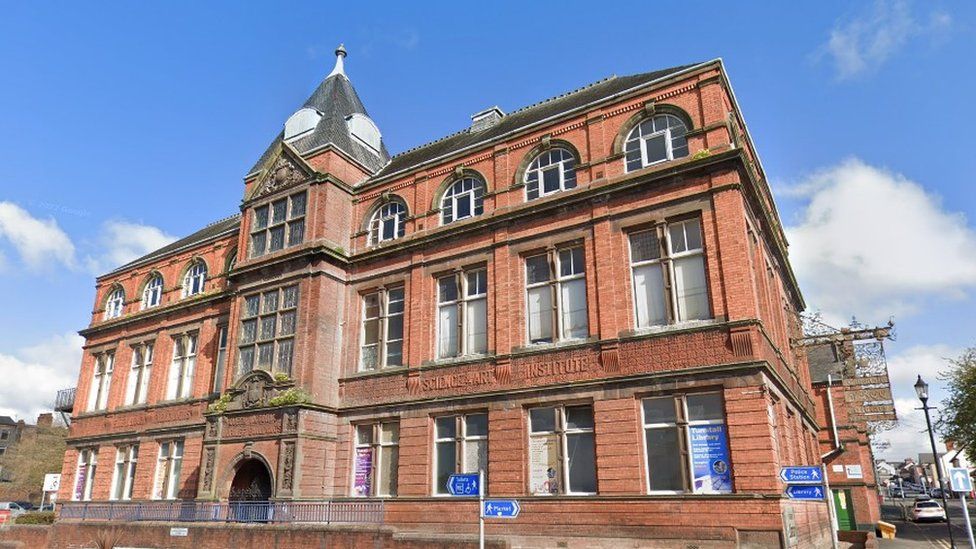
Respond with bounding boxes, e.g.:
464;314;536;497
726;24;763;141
60;56;828;547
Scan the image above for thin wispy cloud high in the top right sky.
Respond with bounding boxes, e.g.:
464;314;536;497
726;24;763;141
818;0;952;80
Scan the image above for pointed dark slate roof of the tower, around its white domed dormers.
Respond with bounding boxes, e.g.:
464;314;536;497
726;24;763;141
248;70;390;174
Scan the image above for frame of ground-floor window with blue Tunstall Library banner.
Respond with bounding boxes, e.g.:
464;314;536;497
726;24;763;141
639;391;732;495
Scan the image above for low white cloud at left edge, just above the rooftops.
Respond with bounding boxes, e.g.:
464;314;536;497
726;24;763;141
0;333;85;423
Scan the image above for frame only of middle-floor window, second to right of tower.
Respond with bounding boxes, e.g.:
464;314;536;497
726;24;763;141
434;267;488;359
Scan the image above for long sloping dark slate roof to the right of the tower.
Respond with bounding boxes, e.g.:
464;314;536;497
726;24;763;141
374;63;701;177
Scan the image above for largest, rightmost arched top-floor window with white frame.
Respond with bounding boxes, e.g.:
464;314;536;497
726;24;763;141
624;114;688;172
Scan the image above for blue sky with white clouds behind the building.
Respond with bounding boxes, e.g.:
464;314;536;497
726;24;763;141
0;2;976;457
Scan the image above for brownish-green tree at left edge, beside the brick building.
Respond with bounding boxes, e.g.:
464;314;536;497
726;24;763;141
0;425;68;503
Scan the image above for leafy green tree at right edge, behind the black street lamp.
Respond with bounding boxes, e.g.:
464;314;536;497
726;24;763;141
937;347;976;461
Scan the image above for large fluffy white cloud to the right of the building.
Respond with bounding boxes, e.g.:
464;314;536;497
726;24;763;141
786;158;976;325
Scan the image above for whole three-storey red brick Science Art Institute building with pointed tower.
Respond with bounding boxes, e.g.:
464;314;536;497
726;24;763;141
53;48;829;547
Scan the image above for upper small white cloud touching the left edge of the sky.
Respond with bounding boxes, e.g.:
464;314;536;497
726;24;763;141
0;201;75;270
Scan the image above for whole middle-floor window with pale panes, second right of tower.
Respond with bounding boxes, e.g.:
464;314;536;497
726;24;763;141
437;269;488;358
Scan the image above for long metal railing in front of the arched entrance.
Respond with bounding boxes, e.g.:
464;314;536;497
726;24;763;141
58;501;383;524
